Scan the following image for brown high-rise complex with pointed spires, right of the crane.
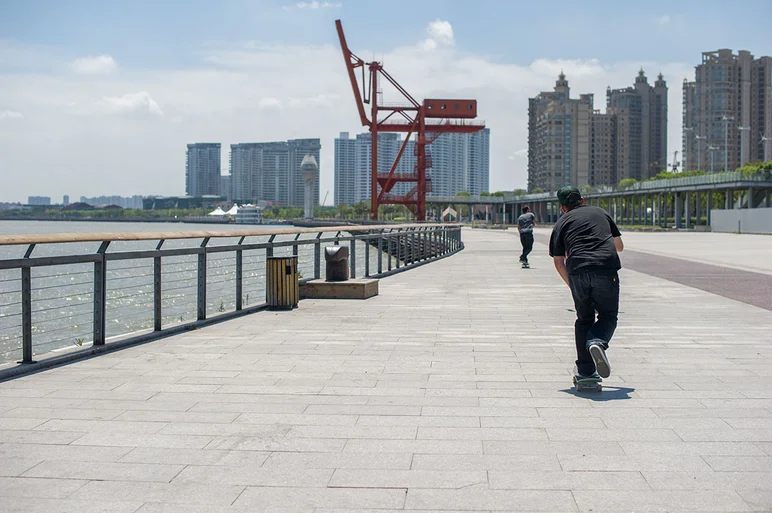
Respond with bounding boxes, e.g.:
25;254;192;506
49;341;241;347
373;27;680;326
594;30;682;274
528;70;667;191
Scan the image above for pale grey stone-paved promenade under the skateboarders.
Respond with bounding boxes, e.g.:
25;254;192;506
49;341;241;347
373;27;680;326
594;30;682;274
0;230;772;513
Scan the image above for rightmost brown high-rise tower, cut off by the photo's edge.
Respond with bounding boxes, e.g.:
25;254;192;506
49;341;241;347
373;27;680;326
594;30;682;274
682;49;772;171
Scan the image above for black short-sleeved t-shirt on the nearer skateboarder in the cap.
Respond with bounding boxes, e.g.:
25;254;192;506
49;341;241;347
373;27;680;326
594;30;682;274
550;205;622;274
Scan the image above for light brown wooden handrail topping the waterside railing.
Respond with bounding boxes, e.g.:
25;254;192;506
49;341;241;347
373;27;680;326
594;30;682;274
0;223;455;246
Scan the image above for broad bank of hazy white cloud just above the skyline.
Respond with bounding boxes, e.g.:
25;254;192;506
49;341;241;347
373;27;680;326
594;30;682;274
0;21;694;201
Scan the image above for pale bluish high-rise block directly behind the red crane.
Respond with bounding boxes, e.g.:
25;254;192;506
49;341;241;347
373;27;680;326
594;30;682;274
335;128;490;205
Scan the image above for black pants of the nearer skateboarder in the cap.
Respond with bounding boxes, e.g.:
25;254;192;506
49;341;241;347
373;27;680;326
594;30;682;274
568;271;619;375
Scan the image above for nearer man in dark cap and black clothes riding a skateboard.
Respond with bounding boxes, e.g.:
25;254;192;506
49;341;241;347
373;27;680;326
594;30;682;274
549;186;624;378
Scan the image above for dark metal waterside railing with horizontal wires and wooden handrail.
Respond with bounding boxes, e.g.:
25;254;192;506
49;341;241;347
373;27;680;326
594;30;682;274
0;224;463;364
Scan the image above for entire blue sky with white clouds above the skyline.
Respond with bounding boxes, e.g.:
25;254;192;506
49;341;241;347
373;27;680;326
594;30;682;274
0;0;772;204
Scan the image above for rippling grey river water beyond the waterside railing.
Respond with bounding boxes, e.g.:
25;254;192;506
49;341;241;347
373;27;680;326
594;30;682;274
0;221;385;363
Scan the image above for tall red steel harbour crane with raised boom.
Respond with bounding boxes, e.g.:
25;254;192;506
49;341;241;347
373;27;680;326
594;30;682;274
335;20;485;221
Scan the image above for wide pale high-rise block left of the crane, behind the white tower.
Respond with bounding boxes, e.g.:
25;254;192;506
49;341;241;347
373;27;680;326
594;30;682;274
229;139;322;206
